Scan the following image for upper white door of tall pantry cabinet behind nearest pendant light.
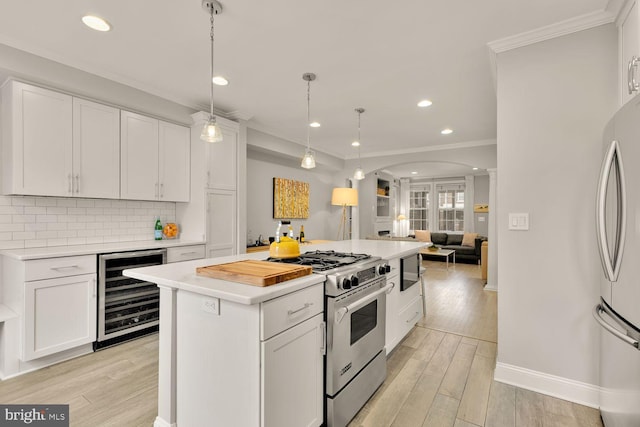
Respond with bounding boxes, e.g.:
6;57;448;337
207;125;238;190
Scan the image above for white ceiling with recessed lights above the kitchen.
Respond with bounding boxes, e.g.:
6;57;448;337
0;0;607;176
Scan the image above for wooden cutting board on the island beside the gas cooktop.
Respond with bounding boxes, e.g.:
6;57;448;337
196;260;311;286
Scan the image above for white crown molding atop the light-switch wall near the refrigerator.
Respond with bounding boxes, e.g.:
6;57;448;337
487;9;624;88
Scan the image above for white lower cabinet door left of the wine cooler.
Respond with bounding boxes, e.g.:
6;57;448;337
22;274;96;361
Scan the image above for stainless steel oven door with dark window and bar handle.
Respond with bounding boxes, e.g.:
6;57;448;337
327;277;393;396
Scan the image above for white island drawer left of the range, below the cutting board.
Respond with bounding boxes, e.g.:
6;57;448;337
260;283;324;340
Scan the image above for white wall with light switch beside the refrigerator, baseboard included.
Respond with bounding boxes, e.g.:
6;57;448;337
498;24;617;406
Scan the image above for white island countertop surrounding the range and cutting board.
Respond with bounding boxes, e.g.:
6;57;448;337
123;240;425;304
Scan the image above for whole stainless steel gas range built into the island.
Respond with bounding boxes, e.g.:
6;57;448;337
270;251;393;427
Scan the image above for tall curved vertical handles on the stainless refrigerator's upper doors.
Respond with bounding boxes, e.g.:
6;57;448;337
596;141;627;282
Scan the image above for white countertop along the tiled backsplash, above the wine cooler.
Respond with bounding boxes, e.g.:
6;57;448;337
0;239;204;261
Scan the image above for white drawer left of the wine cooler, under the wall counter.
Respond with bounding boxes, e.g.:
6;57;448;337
24;255;97;282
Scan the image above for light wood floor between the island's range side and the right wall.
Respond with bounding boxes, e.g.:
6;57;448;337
349;261;602;427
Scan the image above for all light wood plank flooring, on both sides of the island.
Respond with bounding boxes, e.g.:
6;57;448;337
0;261;602;427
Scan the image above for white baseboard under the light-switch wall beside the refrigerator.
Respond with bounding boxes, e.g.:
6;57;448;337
494;362;600;408
